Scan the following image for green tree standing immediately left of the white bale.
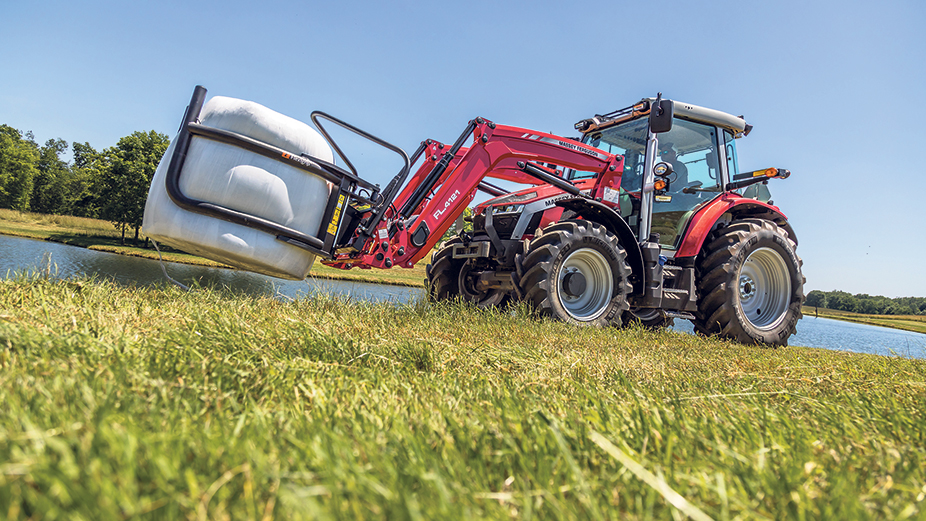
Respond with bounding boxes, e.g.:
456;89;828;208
100;130;170;244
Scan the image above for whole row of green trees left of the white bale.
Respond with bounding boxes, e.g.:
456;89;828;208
0;125;170;243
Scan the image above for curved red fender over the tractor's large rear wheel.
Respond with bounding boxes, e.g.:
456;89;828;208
675;192;797;258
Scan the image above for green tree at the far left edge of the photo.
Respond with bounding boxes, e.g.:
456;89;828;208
0;125;38;211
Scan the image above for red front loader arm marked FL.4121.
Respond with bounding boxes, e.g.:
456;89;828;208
322;118;623;269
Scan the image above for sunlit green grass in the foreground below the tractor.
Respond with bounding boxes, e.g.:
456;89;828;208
0;276;926;519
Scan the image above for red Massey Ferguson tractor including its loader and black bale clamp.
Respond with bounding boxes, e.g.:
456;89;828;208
160;87;804;345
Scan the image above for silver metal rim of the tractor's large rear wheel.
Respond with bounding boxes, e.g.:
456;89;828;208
738;248;791;329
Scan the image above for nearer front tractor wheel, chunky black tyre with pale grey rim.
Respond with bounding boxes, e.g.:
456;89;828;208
518;221;632;327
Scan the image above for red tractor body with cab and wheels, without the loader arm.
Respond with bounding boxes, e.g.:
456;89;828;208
427;98;804;345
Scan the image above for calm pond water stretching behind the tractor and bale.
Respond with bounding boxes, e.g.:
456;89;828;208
0;235;926;358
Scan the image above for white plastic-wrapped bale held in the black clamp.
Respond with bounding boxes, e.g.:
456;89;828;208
142;96;334;280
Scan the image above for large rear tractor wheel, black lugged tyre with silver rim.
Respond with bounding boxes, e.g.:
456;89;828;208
694;219;804;346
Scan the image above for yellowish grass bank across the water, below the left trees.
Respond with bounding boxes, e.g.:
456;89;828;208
0;209;427;287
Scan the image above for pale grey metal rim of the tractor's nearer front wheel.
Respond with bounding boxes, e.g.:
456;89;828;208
557;248;614;321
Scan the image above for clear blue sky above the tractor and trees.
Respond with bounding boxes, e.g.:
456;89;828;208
0;0;926;296
